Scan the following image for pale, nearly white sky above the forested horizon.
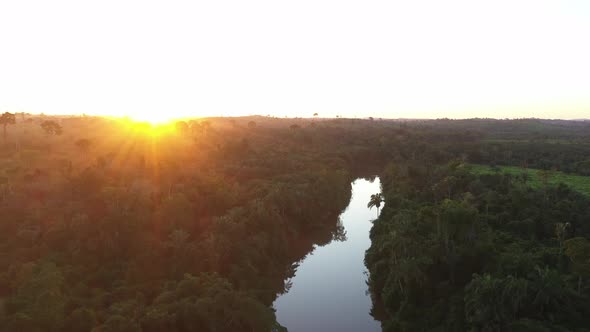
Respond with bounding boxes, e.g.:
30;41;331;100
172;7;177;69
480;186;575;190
0;0;590;119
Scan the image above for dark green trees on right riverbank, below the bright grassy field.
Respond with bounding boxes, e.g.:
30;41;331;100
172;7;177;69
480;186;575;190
365;162;590;331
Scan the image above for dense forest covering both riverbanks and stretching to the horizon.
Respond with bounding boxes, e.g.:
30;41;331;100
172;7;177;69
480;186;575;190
0;113;590;332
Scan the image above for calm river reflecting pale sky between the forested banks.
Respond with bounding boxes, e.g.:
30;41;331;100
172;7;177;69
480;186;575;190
274;178;381;332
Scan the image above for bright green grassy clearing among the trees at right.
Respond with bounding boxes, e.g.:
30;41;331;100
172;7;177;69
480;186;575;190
471;164;590;196
